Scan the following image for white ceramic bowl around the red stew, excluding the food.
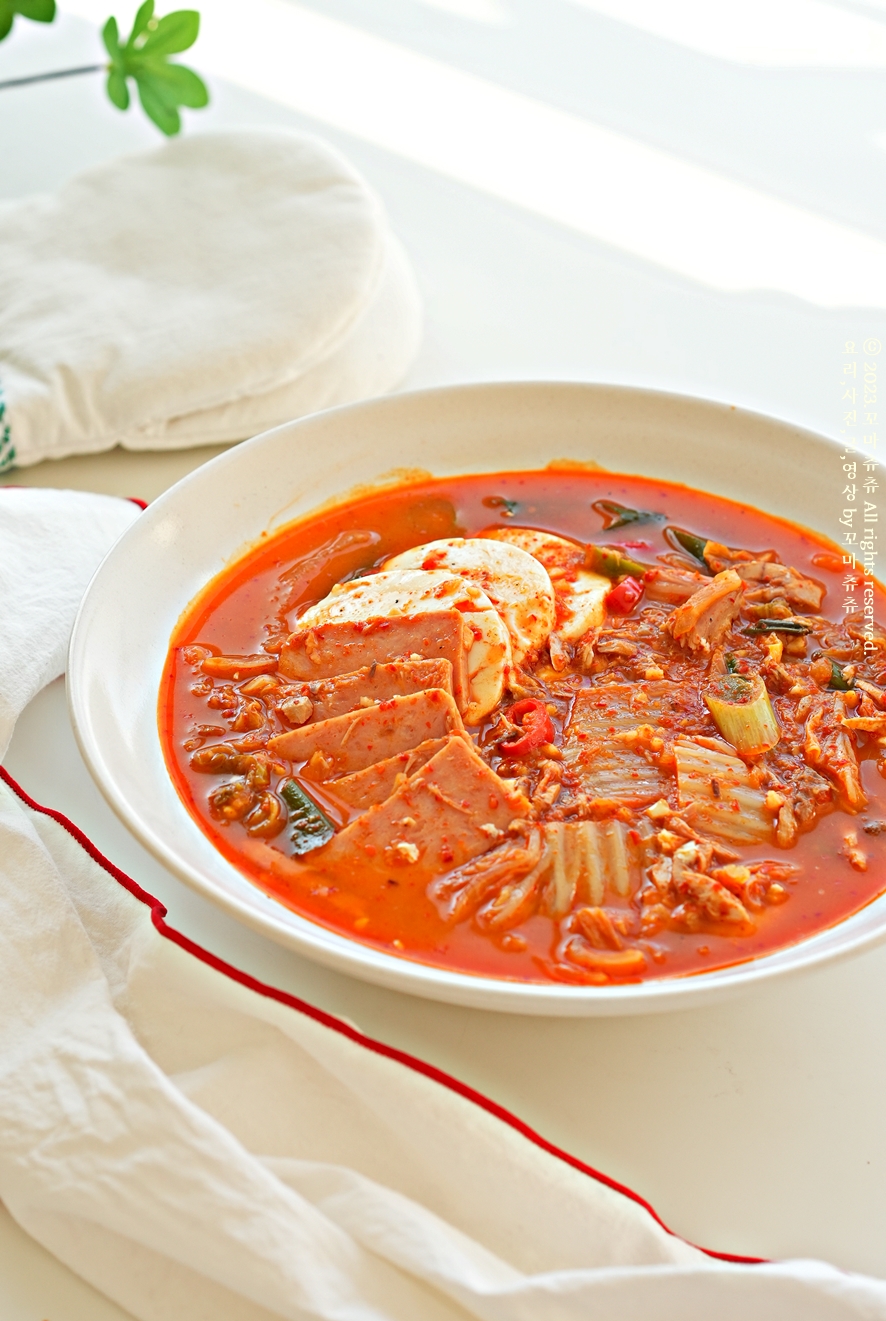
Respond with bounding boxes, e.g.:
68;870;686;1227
67;384;886;1015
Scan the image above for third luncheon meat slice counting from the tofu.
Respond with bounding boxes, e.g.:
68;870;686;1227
268;688;463;781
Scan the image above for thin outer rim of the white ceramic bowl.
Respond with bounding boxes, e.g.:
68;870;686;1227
66;380;886;1016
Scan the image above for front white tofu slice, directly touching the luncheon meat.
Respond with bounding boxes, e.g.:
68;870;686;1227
298;569;511;724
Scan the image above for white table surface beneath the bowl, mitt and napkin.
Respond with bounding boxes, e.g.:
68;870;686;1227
0;0;886;1321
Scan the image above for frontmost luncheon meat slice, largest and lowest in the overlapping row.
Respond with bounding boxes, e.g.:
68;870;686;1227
317;737;529;884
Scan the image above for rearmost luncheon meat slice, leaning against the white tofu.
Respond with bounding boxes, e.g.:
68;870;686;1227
280;610;474;711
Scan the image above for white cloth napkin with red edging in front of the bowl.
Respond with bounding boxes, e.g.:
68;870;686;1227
0;487;886;1321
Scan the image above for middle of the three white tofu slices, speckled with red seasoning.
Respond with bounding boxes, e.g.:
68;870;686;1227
384;536;556;664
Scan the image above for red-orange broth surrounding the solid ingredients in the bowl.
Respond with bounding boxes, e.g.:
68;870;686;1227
160;469;886;984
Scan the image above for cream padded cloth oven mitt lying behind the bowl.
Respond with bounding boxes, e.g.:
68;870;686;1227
0;129;421;470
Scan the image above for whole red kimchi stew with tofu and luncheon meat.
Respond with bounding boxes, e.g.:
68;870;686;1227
160;468;886;985
